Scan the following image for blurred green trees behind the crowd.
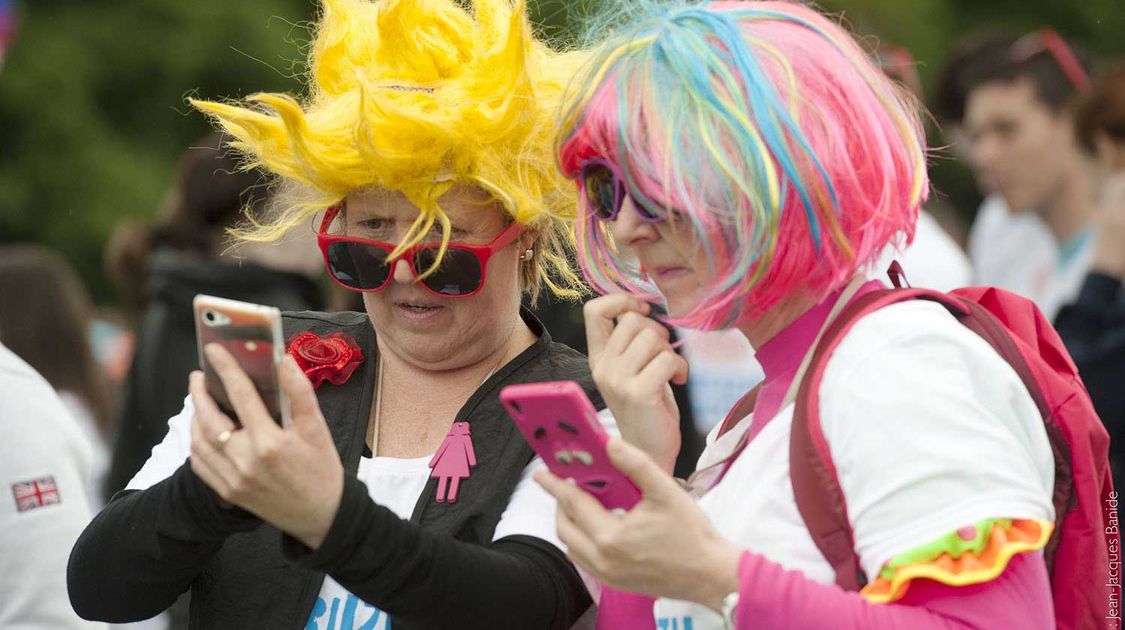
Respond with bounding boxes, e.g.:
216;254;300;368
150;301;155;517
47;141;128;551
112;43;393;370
0;0;1125;303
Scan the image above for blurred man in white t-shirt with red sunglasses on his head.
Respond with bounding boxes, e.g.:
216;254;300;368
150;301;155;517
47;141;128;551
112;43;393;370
964;28;1097;320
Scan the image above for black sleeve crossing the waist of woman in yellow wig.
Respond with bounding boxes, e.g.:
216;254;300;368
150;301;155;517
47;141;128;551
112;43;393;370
284;477;591;630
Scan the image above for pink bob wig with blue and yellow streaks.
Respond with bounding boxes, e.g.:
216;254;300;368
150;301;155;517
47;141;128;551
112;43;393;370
558;1;928;330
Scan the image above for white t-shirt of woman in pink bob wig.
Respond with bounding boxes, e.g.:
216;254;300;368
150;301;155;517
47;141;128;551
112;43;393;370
654;302;1054;630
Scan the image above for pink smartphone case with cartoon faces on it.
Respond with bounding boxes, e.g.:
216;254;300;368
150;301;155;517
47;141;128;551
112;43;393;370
500;380;640;510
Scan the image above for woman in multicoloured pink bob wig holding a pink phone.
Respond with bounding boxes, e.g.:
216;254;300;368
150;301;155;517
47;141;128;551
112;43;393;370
537;2;1054;630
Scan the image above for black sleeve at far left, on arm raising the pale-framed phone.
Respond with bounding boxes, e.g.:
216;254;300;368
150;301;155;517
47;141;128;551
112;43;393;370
66;462;261;623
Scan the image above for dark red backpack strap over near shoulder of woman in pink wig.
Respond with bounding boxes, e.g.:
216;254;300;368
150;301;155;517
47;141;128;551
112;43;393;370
789;289;945;591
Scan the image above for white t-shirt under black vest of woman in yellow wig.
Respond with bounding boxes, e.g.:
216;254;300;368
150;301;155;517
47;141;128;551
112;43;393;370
127;398;603;630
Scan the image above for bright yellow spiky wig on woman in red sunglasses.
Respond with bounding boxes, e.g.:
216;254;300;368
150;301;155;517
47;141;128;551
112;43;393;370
191;0;583;297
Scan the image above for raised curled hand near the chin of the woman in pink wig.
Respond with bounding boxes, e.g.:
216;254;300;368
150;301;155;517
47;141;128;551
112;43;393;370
583;294;687;473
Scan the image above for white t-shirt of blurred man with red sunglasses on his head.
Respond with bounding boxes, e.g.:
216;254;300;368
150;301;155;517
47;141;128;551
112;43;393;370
969;196;1094;320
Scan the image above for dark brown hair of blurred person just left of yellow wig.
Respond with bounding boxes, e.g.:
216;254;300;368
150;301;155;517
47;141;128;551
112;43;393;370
105;132;267;313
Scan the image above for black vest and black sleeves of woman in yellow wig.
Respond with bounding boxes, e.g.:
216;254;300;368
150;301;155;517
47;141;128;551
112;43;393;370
68;313;603;630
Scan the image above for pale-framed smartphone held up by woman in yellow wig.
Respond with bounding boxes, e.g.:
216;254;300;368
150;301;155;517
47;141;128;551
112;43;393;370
191;295;290;426
